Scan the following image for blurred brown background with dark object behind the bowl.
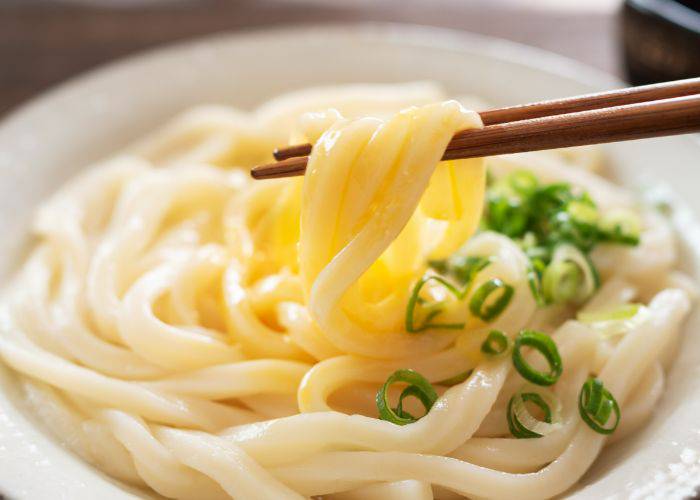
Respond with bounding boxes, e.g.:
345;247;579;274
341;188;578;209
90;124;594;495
0;0;700;115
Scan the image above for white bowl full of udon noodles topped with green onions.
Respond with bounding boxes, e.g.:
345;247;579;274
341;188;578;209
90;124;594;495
0;25;700;500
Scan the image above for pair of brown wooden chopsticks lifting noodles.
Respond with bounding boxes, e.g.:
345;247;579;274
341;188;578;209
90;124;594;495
251;78;700;179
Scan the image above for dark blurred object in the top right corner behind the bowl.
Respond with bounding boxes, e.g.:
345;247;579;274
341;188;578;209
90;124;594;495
621;0;700;85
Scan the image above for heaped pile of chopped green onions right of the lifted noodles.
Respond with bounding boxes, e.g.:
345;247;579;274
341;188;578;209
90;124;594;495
483;171;640;306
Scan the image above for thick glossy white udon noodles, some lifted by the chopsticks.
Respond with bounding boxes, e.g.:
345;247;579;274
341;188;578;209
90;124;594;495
0;83;694;500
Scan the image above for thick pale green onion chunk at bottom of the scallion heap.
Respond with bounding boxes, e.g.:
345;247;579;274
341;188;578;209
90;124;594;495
542;243;600;304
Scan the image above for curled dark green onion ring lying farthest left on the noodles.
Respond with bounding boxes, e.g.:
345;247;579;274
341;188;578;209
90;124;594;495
376;369;438;425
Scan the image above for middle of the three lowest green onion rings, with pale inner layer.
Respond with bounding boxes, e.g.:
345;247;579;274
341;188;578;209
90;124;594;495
506;385;562;439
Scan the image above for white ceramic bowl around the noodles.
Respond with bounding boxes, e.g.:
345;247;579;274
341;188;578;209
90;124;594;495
0;25;700;500
